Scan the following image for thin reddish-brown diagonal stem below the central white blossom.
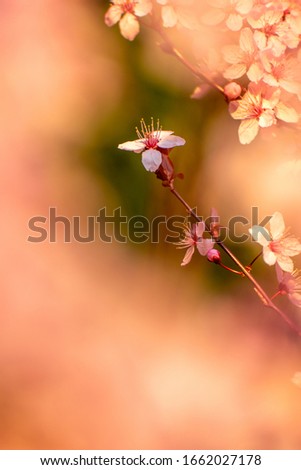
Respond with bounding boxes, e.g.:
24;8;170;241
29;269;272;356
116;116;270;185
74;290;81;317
169;186;301;336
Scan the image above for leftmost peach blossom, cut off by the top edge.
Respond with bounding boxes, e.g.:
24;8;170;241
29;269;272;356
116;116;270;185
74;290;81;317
105;0;153;41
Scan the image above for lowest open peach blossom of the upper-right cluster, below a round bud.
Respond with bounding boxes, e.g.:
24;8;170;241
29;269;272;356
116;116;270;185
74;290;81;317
229;82;299;144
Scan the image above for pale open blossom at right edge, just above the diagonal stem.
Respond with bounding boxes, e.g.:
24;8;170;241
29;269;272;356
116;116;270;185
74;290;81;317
249;212;301;273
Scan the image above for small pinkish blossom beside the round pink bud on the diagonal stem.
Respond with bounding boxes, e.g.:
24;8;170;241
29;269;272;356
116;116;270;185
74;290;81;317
177;222;214;266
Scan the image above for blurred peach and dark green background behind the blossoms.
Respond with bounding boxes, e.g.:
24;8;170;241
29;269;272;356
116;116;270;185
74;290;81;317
0;0;301;449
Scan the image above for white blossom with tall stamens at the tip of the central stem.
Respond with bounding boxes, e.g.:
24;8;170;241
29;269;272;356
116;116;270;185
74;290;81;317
118;119;185;172
